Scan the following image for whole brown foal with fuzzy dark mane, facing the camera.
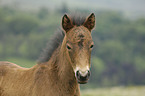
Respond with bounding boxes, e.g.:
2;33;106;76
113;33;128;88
0;13;95;96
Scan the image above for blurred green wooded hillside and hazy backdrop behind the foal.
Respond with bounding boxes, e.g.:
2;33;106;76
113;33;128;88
0;0;145;96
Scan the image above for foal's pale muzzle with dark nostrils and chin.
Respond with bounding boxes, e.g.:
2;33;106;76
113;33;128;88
74;66;90;84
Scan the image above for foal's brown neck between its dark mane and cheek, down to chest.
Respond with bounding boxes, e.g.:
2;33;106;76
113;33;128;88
45;37;79;93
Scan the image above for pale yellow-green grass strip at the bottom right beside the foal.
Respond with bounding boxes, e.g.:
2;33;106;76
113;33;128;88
81;86;145;96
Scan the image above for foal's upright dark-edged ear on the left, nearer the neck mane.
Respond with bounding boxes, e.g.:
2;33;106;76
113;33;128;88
62;14;74;32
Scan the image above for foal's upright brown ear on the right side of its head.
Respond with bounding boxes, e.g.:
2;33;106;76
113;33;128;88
83;13;95;31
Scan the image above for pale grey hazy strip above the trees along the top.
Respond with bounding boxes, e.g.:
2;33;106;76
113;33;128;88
0;0;145;16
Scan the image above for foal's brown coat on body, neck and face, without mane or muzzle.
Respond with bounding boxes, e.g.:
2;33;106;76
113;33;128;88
0;12;95;96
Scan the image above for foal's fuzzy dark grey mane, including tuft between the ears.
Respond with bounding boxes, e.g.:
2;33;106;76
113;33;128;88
37;14;86;64
